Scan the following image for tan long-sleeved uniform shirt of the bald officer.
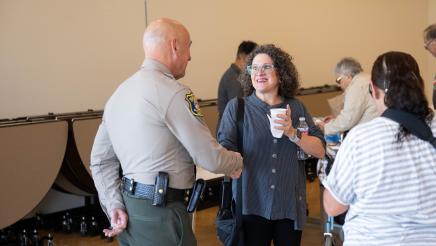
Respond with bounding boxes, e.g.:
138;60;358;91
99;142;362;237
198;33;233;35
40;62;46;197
91;59;242;213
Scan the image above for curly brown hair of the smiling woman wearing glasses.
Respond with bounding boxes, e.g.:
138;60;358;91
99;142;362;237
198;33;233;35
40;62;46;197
240;44;300;98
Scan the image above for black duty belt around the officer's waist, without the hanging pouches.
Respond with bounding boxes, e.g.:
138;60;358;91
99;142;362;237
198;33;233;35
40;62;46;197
122;177;190;203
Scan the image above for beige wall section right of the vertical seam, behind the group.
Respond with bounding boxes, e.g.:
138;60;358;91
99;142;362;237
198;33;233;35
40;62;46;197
147;0;428;98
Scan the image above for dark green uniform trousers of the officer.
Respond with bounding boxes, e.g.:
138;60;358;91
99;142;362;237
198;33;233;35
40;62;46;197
118;192;197;246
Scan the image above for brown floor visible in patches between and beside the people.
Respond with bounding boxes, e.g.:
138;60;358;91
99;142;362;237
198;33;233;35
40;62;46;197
50;180;322;246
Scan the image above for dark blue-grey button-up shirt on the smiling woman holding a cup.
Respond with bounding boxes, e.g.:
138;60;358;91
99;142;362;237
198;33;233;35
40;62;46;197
218;93;324;230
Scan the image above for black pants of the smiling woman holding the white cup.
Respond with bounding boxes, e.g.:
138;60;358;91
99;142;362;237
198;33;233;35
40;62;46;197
242;215;302;246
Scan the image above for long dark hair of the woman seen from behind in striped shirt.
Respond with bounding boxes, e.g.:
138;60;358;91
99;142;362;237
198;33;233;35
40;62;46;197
371;51;433;141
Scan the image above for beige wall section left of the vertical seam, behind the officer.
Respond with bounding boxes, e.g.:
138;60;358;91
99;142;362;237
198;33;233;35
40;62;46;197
0;0;145;118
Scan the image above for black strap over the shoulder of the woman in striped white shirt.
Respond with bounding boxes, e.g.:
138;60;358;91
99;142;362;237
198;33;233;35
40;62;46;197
382;108;436;149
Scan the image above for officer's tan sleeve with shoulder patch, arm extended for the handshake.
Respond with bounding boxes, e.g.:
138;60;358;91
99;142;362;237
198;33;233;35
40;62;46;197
165;90;242;175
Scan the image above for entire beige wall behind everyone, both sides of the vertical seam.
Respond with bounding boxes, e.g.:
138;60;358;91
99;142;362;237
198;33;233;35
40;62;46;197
0;0;436;118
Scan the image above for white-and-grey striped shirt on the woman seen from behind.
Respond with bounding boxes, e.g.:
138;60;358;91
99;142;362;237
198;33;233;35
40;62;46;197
324;117;436;245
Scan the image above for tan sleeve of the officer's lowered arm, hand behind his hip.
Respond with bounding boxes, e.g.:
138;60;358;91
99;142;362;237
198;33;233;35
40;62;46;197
90;120;125;217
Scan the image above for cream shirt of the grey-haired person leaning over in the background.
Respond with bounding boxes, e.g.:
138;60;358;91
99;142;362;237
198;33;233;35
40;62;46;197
324;73;378;135
